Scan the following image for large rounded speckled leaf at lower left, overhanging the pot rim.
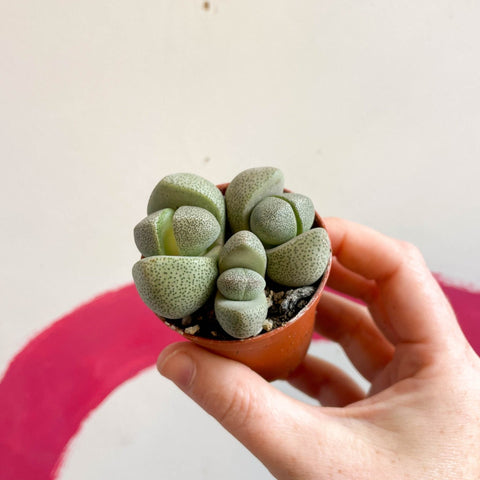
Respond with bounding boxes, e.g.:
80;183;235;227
132;256;218;319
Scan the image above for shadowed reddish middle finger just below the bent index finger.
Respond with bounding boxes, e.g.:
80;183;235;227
315;292;394;382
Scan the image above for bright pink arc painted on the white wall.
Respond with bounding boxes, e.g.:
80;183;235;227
0;280;480;480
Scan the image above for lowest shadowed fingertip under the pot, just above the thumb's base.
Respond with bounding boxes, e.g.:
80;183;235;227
288;355;365;407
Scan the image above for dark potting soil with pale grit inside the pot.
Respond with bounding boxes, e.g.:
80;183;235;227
165;280;320;340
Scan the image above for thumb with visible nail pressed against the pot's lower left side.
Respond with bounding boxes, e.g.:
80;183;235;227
157;342;316;478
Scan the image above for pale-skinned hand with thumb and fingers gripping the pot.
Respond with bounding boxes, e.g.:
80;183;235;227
158;218;480;480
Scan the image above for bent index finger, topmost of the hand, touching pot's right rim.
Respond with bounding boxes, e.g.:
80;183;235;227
326;218;458;344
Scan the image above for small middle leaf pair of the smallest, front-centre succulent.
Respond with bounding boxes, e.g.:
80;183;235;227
217;268;265;300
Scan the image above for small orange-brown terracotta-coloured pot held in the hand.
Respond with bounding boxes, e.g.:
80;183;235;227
160;184;332;381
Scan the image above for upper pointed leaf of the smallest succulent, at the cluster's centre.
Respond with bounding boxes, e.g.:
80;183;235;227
218;230;267;276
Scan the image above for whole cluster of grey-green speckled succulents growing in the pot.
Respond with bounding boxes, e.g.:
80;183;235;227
133;167;331;339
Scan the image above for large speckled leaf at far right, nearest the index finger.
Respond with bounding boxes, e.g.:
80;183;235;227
267;228;331;287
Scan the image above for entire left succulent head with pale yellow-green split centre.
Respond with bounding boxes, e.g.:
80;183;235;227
132;173;225;318
